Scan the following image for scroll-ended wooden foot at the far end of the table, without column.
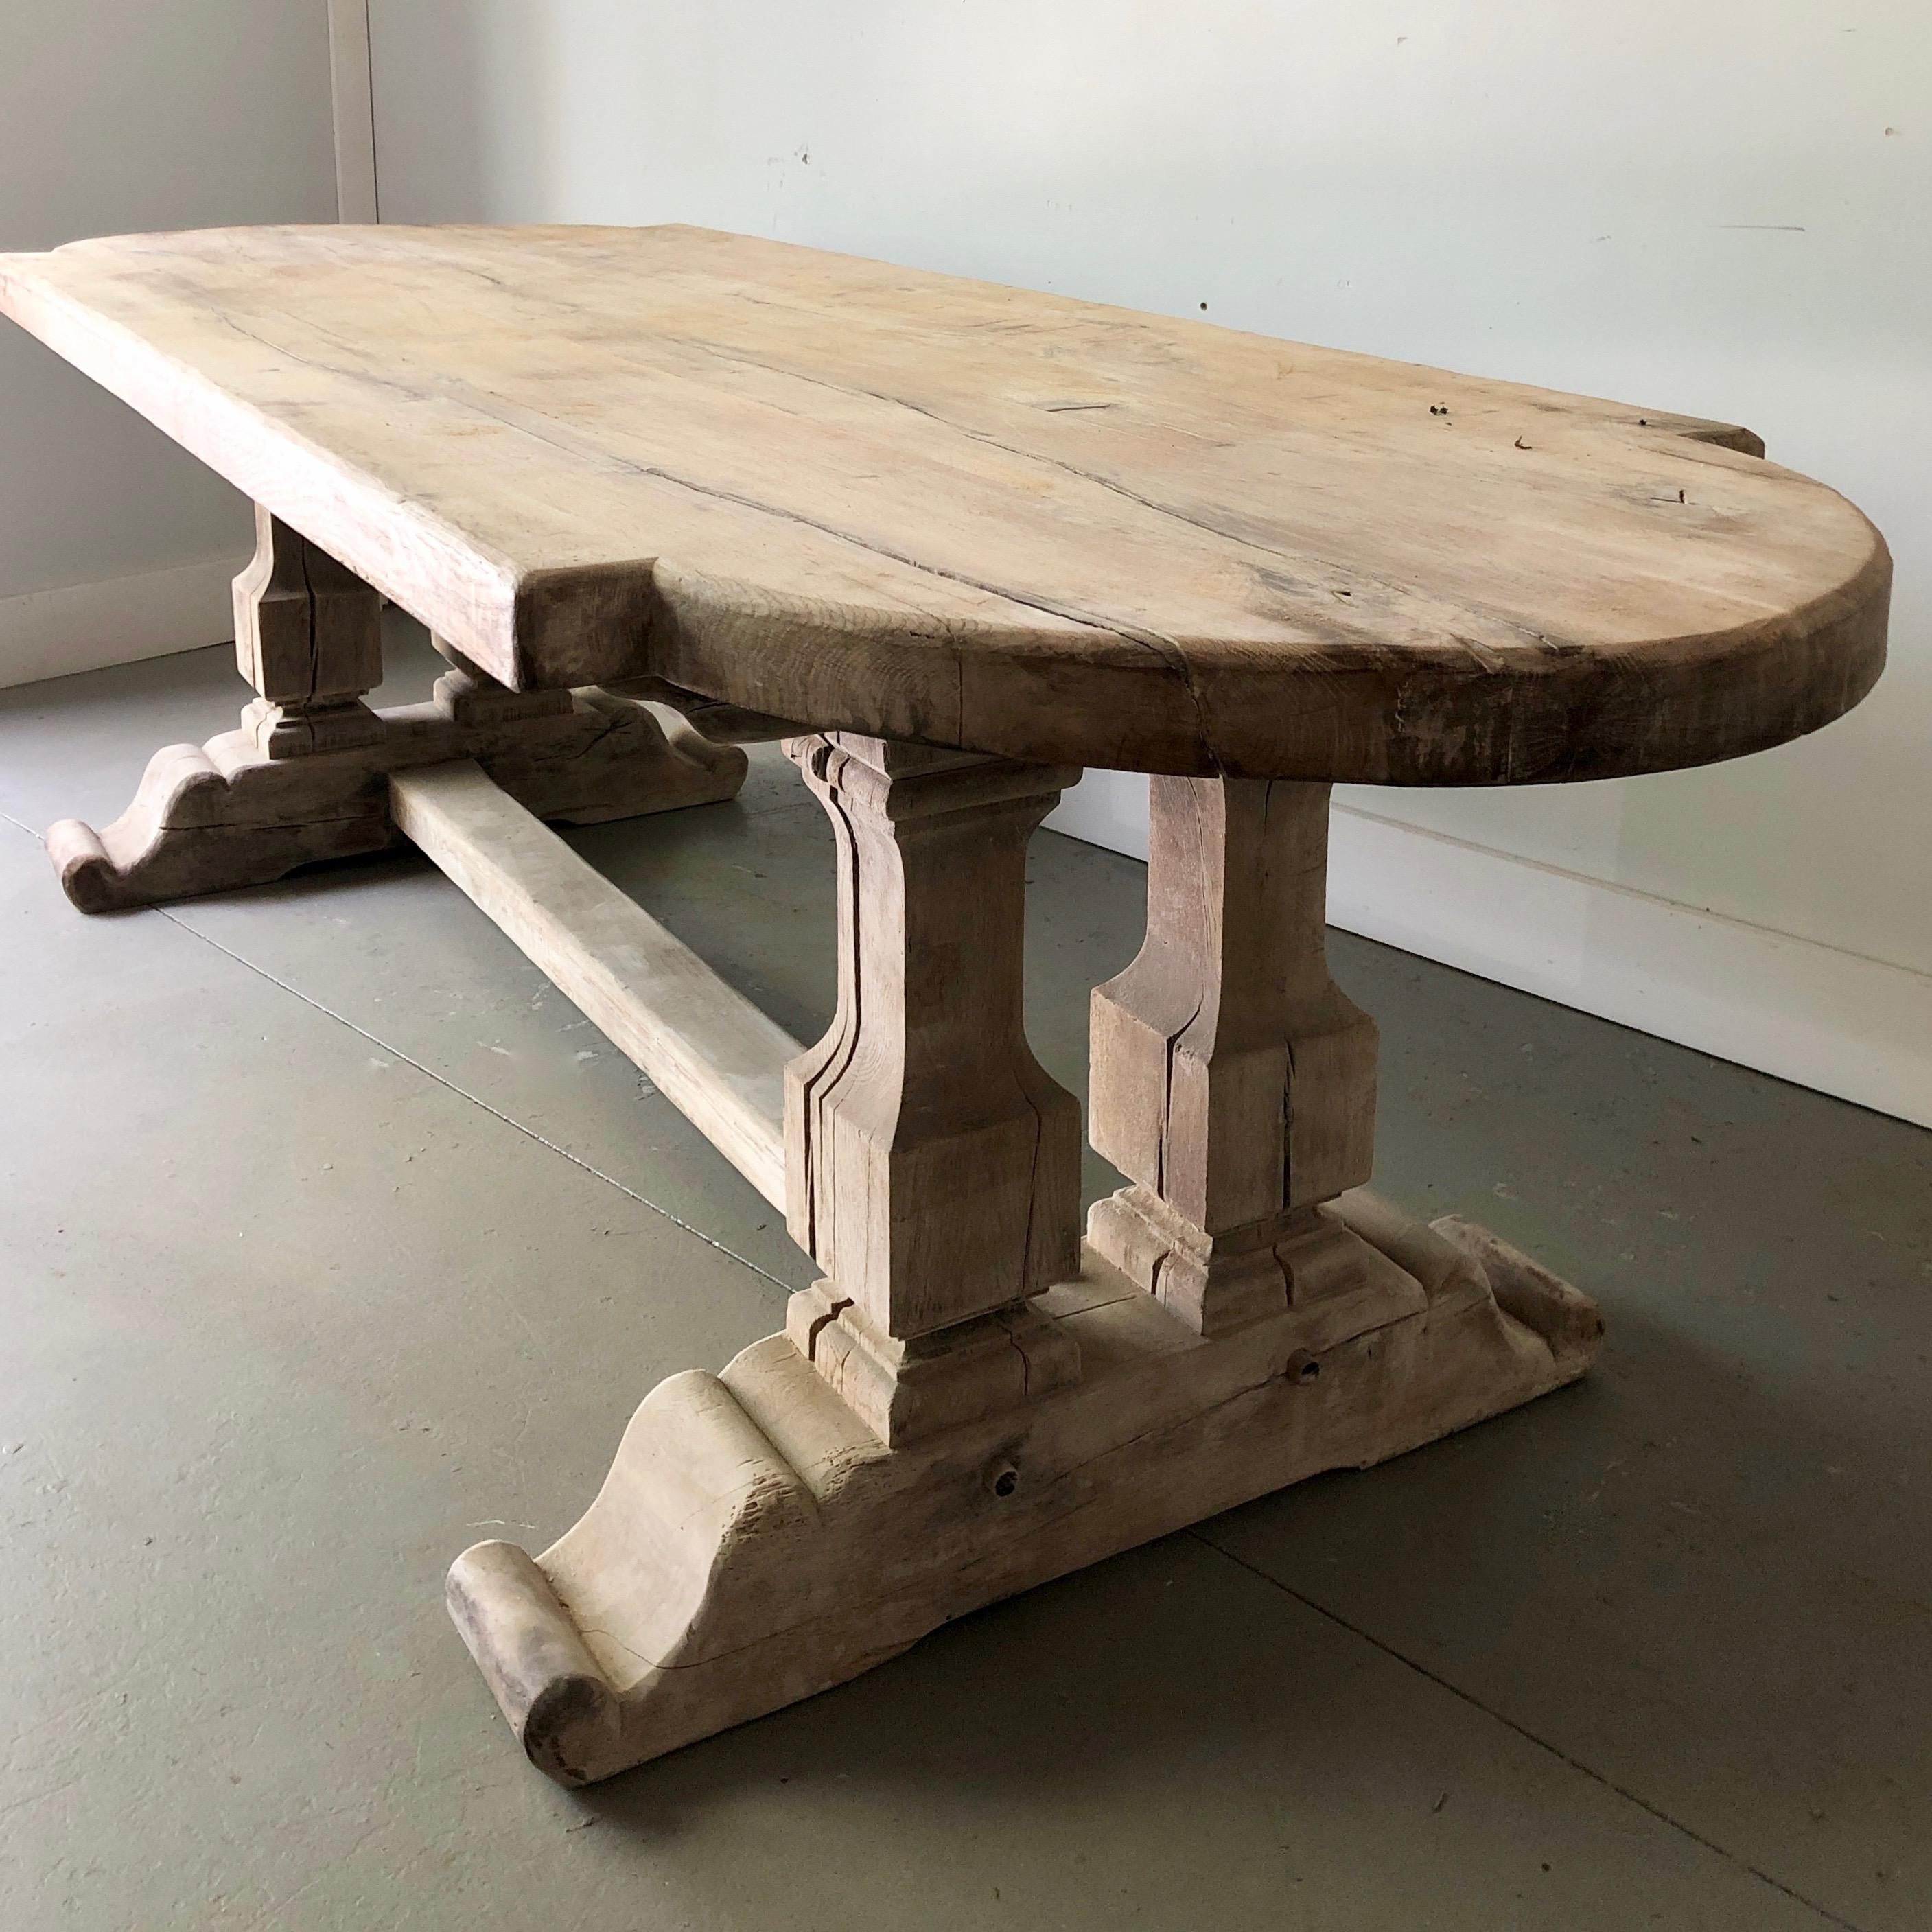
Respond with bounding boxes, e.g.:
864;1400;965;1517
47;680;746;912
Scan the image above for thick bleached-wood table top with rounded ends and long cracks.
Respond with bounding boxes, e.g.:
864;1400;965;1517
0;228;1889;784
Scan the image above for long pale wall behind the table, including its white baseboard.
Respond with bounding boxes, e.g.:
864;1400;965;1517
371;0;1932;1119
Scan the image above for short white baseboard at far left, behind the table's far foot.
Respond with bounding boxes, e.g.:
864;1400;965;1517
0;557;247;686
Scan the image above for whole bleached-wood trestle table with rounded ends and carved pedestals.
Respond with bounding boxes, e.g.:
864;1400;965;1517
0;228;1889;1783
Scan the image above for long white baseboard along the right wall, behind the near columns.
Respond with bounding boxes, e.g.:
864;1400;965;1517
1047;773;1932;1126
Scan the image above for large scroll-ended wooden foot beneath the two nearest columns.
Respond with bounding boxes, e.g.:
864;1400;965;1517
448;1196;1602;1785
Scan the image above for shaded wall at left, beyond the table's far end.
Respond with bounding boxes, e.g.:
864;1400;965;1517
0;0;336;684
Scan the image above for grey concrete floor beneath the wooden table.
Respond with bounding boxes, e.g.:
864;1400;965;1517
0;640;1932;1932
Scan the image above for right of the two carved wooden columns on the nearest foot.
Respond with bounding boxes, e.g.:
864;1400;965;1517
1088;777;1375;1333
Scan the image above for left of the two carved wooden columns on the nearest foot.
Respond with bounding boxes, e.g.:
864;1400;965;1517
787;732;1080;1439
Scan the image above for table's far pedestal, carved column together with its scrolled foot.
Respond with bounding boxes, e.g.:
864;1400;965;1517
47;510;746;912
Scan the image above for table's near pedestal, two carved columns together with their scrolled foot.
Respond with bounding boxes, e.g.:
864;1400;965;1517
448;761;1600;1783
